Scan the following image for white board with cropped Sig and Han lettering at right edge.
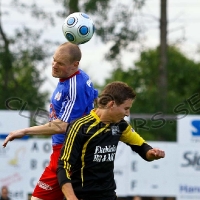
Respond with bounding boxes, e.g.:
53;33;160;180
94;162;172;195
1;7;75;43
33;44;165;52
177;144;200;200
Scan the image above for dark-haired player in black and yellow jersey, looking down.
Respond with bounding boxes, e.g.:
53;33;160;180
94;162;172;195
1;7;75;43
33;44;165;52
57;81;165;200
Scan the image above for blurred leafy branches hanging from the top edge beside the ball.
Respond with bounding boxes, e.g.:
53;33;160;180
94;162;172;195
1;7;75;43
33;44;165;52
54;0;145;62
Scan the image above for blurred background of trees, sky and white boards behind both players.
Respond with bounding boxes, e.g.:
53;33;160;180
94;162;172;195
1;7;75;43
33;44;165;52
0;0;200;200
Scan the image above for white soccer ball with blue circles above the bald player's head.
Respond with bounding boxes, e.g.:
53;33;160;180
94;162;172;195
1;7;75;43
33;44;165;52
62;12;95;44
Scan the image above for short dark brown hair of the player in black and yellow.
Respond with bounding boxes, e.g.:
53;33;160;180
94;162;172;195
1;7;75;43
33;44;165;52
98;81;136;107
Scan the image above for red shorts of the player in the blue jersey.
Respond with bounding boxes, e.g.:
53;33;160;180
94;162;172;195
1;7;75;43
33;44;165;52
32;144;64;200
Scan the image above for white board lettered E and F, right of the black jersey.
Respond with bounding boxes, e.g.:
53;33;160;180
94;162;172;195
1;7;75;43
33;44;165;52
115;142;178;196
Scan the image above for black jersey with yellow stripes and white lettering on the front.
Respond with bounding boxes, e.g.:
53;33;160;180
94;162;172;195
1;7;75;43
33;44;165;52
57;110;152;199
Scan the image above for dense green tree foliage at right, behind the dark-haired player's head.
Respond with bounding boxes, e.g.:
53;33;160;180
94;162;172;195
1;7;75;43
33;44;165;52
103;46;200;141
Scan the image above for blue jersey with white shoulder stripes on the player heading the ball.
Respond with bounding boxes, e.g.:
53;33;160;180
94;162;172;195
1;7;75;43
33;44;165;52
49;69;98;145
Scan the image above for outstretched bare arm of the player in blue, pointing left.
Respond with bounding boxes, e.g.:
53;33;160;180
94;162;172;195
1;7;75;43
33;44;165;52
3;119;68;147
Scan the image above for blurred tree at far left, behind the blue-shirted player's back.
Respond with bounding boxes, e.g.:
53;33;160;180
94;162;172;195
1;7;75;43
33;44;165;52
0;2;57;111
